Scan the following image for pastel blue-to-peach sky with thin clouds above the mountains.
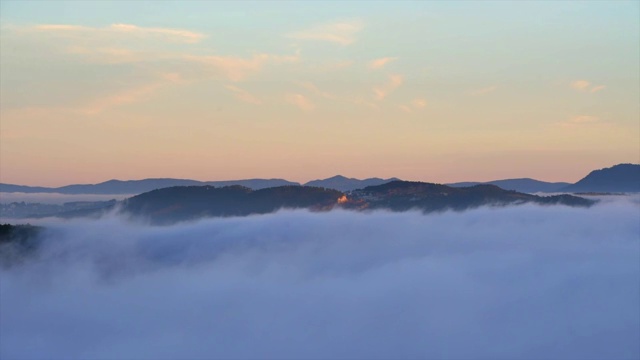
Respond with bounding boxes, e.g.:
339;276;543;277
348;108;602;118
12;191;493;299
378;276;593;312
0;0;640;186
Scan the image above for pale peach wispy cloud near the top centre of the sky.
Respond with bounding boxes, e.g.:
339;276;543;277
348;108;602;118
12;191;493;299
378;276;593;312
287;20;364;46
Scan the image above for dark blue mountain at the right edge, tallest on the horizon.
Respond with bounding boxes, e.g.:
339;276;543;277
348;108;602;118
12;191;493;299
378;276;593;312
562;164;640;192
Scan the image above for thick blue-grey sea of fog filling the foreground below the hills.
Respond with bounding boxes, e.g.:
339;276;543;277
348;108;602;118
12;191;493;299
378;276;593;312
0;197;640;360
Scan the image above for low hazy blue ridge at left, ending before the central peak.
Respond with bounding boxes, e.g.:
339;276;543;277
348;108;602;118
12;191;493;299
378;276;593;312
0;179;300;195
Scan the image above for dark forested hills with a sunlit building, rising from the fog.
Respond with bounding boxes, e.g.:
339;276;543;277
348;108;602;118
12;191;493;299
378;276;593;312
120;181;594;224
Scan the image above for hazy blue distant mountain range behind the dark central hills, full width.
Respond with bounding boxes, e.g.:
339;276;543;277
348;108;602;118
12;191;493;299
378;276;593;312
0;164;640;195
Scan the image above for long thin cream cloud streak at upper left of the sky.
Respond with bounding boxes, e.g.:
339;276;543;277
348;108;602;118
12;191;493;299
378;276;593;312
33;24;205;44
